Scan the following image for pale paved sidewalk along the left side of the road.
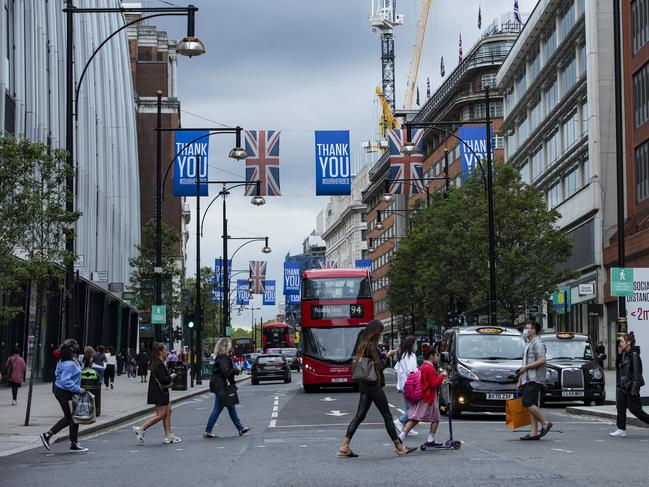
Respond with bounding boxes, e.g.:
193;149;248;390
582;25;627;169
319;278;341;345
0;375;250;457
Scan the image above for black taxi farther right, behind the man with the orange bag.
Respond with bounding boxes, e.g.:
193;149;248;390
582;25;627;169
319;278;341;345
541;332;606;406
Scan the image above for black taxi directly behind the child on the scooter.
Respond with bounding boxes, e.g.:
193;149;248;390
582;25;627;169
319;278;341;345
440;326;525;418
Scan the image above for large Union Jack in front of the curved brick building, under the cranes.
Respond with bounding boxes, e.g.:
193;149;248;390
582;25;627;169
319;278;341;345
388;129;426;198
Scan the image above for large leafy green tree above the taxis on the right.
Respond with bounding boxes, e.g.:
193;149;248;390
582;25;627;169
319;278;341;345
388;164;572;323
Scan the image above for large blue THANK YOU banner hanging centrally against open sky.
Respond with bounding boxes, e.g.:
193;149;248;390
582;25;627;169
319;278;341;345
315;130;352;196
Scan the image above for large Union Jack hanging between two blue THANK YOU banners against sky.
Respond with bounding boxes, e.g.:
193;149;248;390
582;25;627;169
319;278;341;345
245;130;282;196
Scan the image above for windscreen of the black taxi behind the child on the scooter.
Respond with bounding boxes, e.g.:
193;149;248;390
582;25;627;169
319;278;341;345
457;334;525;360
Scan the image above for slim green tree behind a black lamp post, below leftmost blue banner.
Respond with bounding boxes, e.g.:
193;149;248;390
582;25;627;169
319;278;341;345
129;219;183;320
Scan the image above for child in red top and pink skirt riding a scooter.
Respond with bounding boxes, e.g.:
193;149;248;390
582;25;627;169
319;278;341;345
399;347;446;448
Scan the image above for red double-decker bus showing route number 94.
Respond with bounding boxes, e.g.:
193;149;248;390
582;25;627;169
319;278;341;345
301;269;374;392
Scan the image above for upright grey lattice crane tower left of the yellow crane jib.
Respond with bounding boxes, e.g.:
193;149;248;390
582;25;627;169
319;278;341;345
370;0;404;111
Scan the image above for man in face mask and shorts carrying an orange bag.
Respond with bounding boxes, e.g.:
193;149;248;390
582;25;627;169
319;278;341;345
516;321;552;440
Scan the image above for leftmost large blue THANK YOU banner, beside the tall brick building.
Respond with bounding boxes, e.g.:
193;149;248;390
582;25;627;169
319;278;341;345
174;130;209;196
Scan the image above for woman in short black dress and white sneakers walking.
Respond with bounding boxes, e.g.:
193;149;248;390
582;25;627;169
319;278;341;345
133;342;182;444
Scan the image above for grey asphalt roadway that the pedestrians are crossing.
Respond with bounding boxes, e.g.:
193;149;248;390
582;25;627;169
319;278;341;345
0;373;649;487
